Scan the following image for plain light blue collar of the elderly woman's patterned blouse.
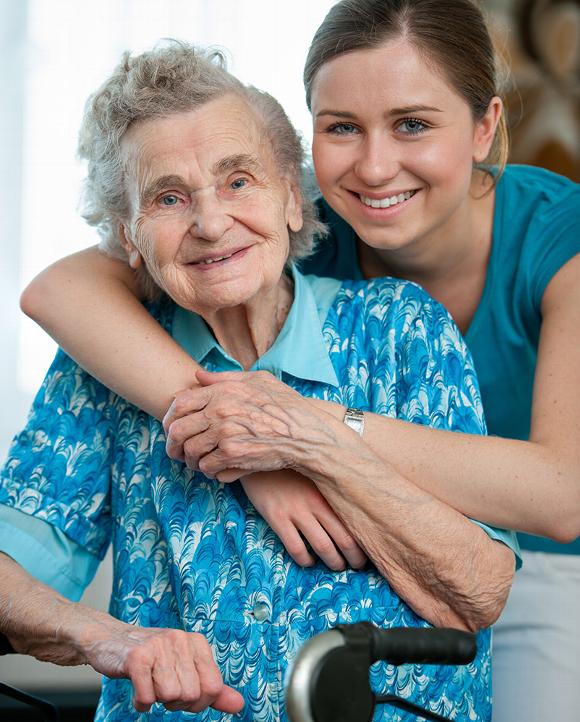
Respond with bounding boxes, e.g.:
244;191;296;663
172;266;340;386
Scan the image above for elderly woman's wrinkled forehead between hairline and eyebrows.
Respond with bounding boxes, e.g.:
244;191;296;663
121;94;274;183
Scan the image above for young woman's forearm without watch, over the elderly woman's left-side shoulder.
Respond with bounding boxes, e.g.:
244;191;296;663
21;248;199;419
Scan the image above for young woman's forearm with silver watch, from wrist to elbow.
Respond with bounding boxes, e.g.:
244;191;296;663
316;402;580;543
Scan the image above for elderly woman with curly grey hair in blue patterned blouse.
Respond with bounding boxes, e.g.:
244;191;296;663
0;43;514;722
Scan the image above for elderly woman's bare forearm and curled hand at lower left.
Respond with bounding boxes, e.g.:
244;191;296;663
0;553;243;712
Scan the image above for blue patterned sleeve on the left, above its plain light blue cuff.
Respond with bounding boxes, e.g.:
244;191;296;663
0;350;120;559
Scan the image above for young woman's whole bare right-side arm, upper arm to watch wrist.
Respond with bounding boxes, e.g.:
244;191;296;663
334;255;580;543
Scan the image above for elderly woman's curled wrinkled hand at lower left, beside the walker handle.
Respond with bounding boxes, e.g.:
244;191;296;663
84;618;244;713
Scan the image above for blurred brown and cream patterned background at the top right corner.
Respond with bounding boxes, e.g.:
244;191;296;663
486;0;580;182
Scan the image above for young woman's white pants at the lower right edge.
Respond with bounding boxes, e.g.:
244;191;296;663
492;551;580;722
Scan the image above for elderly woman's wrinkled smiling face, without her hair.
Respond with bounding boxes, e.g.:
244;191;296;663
123;95;302;314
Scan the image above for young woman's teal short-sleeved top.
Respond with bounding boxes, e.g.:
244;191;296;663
302;165;580;554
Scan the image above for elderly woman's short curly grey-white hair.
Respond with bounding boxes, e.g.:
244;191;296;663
78;40;325;297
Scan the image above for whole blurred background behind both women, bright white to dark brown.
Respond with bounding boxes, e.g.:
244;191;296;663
0;0;580;722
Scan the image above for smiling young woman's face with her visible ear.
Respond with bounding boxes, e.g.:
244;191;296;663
312;39;499;251
